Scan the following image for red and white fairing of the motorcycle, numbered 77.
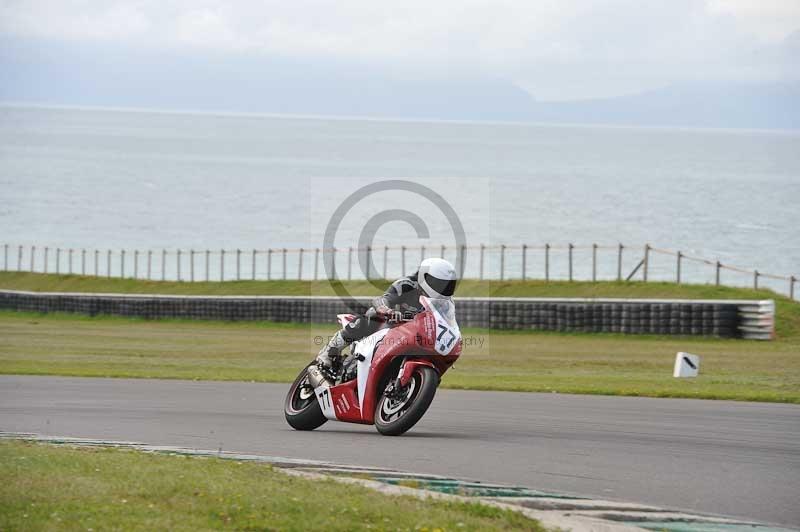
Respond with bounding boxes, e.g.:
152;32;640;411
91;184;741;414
314;296;461;424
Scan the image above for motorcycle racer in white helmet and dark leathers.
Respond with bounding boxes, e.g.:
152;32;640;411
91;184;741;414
317;258;458;369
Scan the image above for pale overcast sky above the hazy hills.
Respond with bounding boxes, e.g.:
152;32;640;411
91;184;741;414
0;0;800;100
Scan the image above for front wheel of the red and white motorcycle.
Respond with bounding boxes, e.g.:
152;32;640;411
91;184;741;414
375;366;439;436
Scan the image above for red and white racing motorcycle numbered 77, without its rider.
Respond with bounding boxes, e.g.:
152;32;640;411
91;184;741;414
284;296;461;436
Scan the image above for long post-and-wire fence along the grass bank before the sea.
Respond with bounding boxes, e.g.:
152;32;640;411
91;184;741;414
2;243;798;299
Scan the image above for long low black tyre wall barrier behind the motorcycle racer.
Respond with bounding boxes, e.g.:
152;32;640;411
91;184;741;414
0;290;775;340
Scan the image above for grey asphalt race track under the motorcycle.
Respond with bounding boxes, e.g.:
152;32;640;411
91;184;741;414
0;376;800;527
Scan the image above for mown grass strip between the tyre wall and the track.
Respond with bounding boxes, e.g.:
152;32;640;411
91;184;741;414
0;311;800;403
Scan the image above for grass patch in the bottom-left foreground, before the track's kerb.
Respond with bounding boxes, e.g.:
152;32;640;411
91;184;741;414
0;441;544;531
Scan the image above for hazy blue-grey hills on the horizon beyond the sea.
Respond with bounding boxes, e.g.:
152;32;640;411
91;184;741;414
0;39;800;129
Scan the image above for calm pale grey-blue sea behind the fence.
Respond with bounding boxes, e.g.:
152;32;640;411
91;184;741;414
0;105;800;292
